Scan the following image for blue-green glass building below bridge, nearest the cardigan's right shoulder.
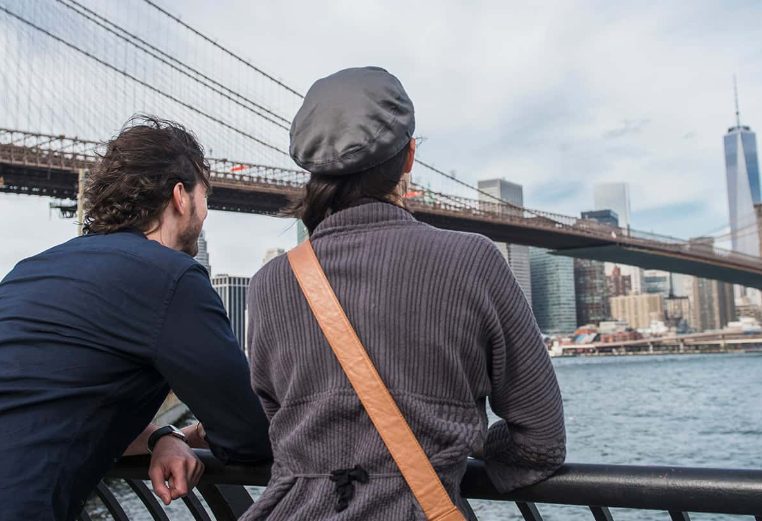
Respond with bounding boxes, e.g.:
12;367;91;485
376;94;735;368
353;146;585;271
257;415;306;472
529;248;577;335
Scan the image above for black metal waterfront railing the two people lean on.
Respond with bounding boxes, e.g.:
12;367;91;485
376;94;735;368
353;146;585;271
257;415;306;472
79;450;762;521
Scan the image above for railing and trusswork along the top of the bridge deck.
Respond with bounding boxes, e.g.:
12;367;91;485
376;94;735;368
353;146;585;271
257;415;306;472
0;128;762;270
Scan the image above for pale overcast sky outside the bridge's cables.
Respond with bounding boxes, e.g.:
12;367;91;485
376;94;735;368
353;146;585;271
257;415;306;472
0;0;762;275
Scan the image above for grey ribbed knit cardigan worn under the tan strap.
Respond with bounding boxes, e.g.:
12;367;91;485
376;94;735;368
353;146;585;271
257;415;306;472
242;202;565;521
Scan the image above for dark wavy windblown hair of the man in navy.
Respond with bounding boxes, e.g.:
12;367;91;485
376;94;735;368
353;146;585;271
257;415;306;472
83;115;210;233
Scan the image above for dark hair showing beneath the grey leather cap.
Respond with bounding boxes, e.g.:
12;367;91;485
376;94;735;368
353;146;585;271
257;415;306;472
285;142;410;233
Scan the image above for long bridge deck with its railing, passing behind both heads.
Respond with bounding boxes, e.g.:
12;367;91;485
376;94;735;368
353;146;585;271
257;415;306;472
0;129;762;288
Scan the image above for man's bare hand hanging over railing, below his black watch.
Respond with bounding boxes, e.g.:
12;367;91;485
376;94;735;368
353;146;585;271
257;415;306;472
148;436;204;505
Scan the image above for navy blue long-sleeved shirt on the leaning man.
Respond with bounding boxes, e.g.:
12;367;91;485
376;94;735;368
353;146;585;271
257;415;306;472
0;231;271;521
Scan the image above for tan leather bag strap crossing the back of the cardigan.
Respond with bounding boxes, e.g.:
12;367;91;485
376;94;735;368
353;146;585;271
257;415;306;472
288;240;465;521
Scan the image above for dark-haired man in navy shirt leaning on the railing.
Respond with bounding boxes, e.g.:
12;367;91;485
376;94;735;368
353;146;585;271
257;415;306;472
0;117;271;521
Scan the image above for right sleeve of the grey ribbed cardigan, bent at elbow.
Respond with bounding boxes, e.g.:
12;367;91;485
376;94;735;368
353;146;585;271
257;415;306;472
483;240;566;492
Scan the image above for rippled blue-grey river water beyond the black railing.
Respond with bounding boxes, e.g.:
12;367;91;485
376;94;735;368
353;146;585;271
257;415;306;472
90;353;762;521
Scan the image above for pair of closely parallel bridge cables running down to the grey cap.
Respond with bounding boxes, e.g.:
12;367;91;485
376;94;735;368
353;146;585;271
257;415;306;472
56;0;290;130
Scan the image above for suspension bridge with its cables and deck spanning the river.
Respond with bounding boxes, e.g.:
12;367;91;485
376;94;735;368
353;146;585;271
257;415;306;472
0;0;762;288
